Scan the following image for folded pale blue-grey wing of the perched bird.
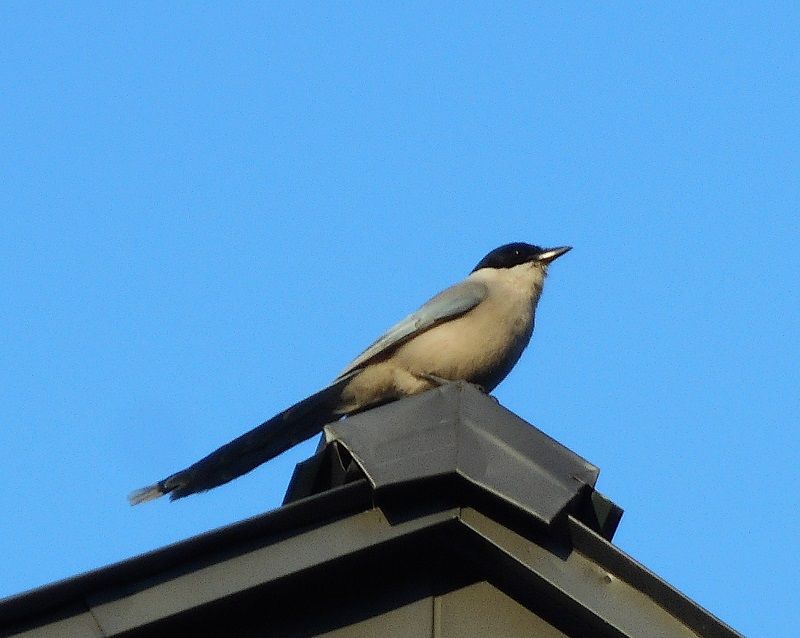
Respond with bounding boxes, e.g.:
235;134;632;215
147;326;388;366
336;279;487;381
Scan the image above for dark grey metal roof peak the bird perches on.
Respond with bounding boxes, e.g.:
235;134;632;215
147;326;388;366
0;383;738;638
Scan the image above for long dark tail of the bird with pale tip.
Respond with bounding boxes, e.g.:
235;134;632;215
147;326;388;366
128;375;353;505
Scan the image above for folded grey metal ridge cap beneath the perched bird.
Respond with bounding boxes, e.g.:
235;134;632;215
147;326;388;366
325;382;599;525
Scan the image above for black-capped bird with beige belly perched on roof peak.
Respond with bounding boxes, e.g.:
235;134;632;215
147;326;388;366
128;242;571;505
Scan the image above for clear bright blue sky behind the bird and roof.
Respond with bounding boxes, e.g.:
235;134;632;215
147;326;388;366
0;2;800;637
